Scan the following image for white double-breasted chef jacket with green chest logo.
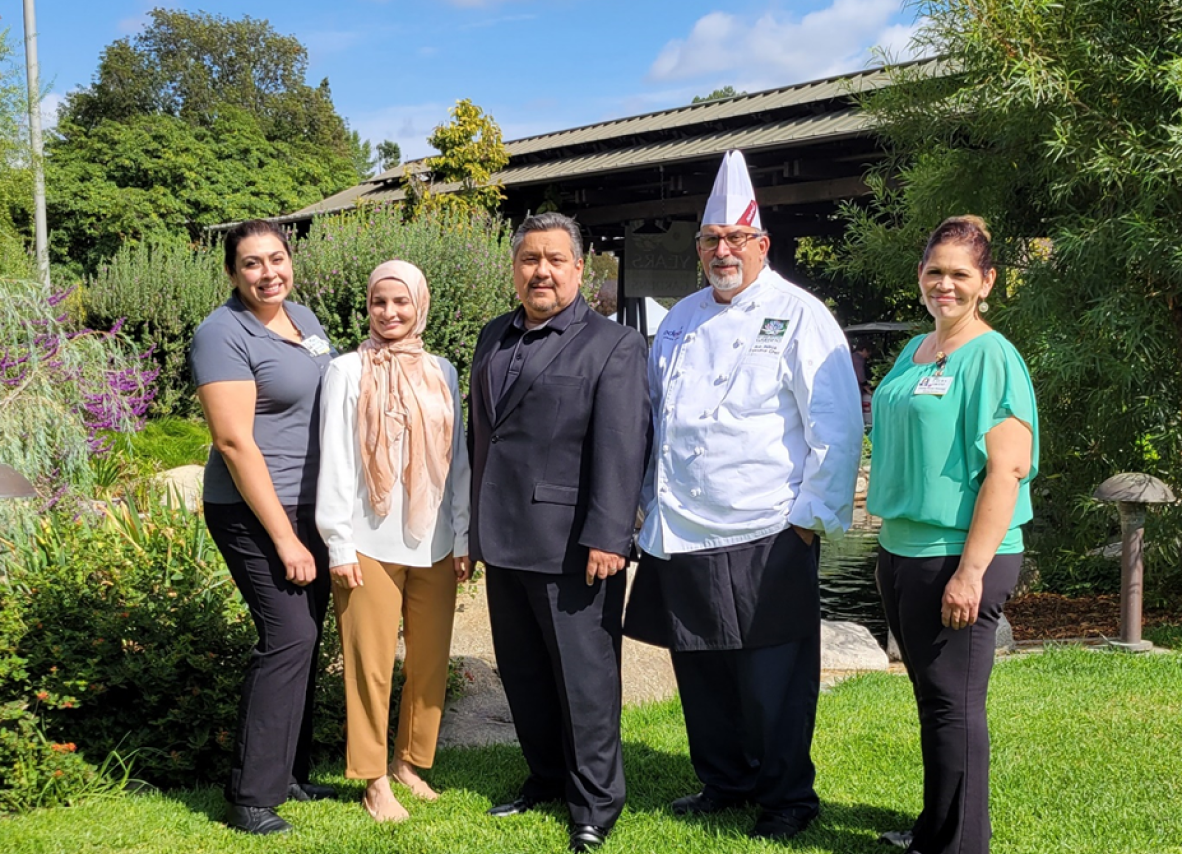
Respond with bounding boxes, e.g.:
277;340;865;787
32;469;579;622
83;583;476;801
639;267;863;558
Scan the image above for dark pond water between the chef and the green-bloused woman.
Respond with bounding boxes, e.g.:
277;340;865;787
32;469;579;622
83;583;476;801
820;530;887;644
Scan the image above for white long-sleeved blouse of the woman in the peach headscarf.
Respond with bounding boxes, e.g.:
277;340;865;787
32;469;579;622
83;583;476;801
316;353;472;567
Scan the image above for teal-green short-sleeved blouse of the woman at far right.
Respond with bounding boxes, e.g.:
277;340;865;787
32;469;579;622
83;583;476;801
866;332;1038;558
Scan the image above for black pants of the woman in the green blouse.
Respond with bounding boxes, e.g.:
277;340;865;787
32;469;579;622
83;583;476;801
876;550;1022;854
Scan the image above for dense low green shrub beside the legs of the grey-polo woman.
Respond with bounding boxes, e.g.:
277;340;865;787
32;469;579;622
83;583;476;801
0;493;344;787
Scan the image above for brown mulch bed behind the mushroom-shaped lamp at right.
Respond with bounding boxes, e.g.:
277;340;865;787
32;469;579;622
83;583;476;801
1006;593;1182;640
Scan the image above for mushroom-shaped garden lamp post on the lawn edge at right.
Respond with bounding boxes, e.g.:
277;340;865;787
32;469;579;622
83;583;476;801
1092;472;1175;652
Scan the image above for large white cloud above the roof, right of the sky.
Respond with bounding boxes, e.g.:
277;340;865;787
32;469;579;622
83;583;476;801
649;0;911;91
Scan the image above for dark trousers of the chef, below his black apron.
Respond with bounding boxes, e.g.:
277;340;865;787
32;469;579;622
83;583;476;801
671;637;820;817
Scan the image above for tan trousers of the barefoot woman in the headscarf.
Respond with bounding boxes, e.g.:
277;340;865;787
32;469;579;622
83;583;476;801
332;554;456;780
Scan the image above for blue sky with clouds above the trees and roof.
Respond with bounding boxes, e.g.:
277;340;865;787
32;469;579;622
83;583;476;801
27;0;914;157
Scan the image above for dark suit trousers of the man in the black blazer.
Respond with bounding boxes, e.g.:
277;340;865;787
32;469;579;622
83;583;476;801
487;567;625;828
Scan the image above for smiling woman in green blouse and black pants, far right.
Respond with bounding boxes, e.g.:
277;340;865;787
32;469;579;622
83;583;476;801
866;216;1038;854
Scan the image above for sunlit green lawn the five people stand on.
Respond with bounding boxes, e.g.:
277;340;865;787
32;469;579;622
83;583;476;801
0;648;1182;854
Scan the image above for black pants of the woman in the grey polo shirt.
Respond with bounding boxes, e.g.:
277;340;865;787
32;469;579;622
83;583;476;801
206;503;331;807
